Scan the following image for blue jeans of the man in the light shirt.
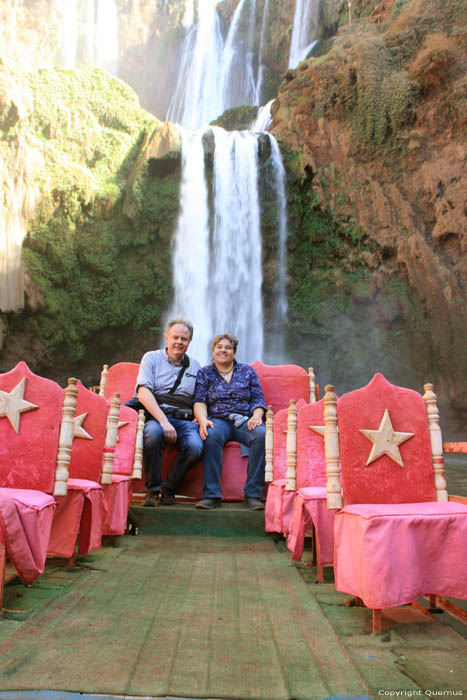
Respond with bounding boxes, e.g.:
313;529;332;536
143;417;203;493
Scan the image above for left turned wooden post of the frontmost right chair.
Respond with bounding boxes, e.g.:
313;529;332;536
324;384;342;510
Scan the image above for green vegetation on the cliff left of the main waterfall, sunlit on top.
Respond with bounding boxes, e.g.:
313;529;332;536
3;68;180;377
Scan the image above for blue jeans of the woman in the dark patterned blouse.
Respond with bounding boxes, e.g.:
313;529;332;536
203;418;266;498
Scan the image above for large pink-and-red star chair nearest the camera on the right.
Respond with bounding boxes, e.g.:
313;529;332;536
324;374;467;632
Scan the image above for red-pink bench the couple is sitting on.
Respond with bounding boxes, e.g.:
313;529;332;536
99;362;315;501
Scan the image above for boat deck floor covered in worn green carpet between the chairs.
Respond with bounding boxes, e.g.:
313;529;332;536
0;504;467;700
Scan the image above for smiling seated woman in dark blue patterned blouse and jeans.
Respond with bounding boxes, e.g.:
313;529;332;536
193;333;266;510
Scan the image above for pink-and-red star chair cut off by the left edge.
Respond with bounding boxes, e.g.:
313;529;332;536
0;362;77;600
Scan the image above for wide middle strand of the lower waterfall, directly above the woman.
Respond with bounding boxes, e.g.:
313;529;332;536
209;128;263;362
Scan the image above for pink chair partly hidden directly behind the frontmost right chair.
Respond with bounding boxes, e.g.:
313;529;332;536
287;399;334;583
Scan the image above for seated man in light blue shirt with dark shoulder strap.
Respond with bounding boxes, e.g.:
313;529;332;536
136;318;203;507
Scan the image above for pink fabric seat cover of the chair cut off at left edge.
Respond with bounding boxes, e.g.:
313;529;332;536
0;488;56;585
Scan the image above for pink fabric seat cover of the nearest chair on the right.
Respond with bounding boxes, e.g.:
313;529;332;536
335;501;467;609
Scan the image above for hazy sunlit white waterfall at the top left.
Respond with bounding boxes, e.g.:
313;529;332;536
55;0;119;75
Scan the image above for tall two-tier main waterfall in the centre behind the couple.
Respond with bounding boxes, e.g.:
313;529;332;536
167;0;287;363
